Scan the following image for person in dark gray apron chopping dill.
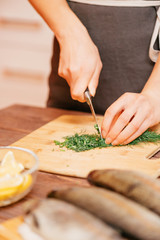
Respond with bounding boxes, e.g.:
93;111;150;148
30;0;160;145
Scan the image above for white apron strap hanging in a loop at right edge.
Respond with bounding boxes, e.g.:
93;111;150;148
149;7;160;62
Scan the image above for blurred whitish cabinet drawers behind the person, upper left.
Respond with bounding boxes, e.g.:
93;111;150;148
0;0;53;109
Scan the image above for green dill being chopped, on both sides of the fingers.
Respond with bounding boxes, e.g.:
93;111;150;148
54;125;160;152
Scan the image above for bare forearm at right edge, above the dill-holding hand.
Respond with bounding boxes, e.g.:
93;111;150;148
142;54;160;97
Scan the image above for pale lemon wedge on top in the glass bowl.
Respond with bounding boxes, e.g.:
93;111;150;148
0;151;24;176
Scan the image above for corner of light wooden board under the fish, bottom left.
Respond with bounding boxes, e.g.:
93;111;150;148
0;217;23;240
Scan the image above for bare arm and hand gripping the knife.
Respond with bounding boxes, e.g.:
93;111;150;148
29;0;102;102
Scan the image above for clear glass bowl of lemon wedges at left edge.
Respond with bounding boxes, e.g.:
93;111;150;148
0;147;39;207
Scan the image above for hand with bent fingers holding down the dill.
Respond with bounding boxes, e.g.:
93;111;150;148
102;93;160;145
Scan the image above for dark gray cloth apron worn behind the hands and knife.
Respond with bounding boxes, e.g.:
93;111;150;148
47;1;159;114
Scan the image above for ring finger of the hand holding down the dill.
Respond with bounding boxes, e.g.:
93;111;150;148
112;111;146;145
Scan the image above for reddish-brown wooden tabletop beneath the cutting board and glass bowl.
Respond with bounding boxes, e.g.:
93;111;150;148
0;105;88;222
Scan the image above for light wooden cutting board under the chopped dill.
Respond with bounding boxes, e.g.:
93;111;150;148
10;115;160;177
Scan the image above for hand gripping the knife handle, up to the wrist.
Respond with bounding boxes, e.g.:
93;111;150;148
58;22;102;102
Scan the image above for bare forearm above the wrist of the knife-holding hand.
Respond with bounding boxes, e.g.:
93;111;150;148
29;0;85;41
